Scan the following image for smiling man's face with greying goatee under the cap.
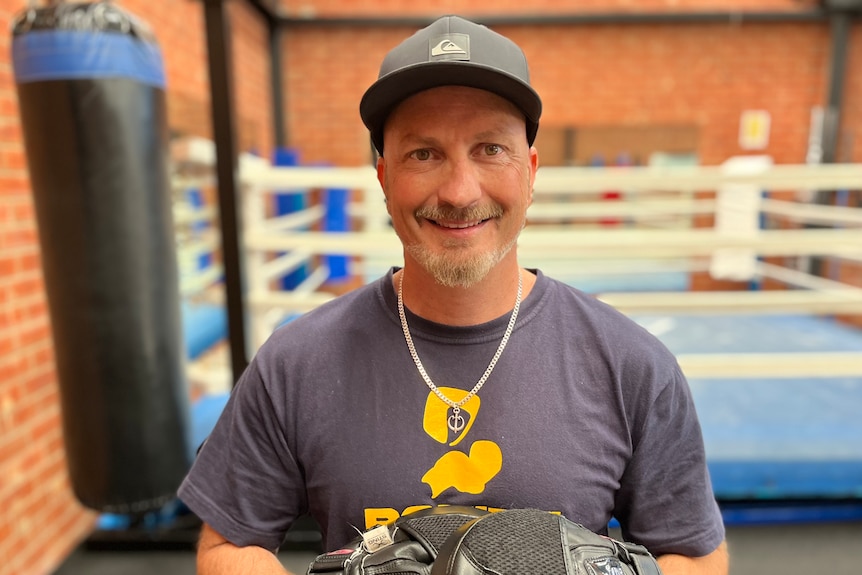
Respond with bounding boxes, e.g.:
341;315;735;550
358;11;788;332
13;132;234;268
377;86;538;287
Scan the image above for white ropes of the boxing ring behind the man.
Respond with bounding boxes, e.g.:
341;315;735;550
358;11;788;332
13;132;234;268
164;158;862;377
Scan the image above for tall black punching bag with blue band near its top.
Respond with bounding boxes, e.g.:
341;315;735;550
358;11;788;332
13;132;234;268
12;2;190;514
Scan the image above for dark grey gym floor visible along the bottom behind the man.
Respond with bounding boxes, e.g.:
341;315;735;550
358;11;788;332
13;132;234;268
54;521;862;575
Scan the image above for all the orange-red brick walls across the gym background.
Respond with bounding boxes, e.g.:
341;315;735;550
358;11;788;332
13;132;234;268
0;0;862;575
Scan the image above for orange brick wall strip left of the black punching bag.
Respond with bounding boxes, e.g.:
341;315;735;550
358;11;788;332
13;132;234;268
0;0;92;574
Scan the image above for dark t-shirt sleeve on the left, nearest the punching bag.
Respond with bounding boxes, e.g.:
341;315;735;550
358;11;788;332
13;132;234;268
178;361;307;550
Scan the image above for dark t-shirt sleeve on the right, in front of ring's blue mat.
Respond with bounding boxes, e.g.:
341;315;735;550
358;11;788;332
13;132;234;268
615;362;724;557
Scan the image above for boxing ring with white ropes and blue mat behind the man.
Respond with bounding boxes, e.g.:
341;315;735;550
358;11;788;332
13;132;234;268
176;157;862;521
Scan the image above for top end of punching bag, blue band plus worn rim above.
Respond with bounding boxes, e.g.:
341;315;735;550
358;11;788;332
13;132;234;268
12;3;165;89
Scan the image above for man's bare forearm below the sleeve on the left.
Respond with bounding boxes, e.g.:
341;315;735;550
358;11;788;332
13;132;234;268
197;523;289;575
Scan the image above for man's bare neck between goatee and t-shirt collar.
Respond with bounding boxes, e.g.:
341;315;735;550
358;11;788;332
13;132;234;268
394;258;536;326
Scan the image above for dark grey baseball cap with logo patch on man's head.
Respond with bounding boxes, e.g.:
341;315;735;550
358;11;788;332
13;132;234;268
359;16;542;154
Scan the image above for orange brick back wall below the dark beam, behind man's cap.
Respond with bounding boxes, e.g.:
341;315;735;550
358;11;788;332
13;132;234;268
284;18;844;164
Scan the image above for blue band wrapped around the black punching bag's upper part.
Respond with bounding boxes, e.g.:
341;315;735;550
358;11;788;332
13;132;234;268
12;30;165;89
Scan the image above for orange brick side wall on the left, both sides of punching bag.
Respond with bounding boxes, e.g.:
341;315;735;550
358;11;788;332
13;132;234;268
0;0;273;575
